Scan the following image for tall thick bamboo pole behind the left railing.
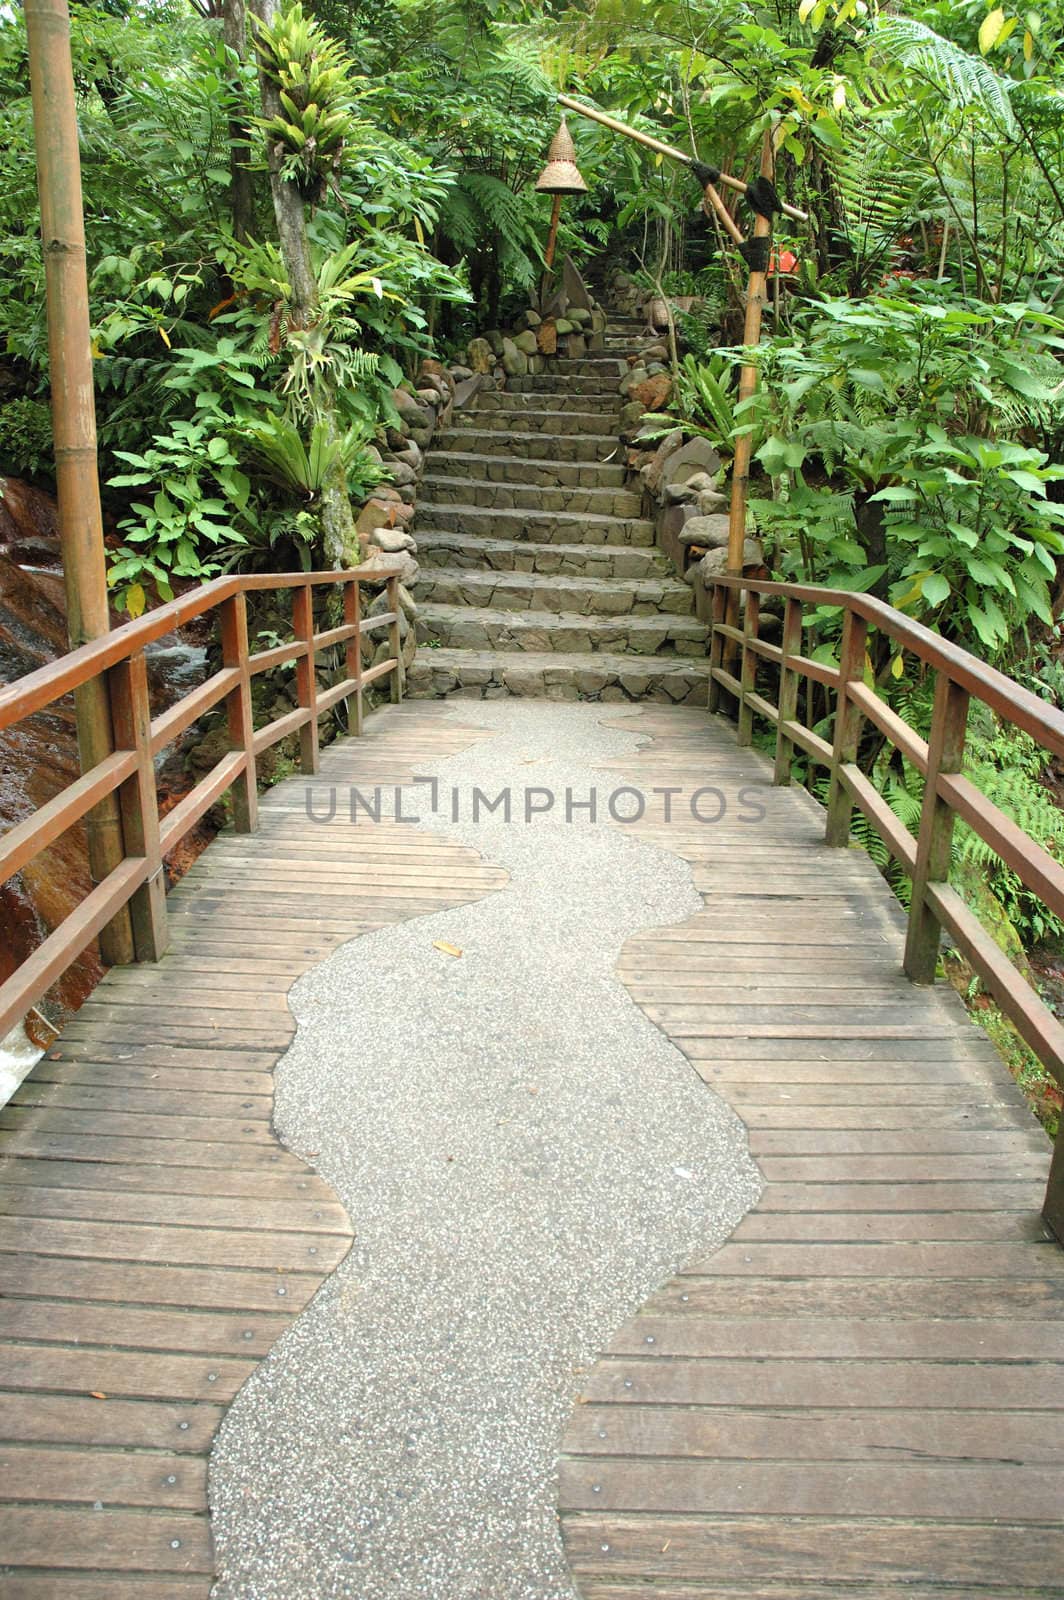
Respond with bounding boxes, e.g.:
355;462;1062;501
26;0;134;965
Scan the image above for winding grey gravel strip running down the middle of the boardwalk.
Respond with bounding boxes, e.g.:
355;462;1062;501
210;701;760;1600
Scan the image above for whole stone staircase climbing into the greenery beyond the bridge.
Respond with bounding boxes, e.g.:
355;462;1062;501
408;322;709;704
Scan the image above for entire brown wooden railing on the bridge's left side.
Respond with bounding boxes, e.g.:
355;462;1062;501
0;566;402;1038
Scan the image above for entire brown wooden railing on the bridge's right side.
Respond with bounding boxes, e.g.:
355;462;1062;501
707;578;1064;1240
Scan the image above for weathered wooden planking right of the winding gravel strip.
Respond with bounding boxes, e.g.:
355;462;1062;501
560;706;1064;1600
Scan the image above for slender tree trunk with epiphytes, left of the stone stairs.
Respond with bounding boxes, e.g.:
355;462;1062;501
253;0;362;570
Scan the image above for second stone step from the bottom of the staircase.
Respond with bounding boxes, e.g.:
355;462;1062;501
416;603;709;661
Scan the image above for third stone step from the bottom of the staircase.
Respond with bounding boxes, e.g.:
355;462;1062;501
414;566;694;622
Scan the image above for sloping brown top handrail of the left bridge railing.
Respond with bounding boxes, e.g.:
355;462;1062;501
0;565;402;733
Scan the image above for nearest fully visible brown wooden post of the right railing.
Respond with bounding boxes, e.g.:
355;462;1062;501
906;669;970;984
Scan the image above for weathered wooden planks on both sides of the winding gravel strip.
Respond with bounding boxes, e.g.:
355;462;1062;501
0;702;1064;1600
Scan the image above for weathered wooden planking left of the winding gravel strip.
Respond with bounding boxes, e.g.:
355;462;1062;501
0;702;506;1600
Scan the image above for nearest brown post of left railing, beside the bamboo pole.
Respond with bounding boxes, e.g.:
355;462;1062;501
107;650;170;962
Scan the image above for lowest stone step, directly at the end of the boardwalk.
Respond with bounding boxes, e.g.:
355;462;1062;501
406;650;709;704
